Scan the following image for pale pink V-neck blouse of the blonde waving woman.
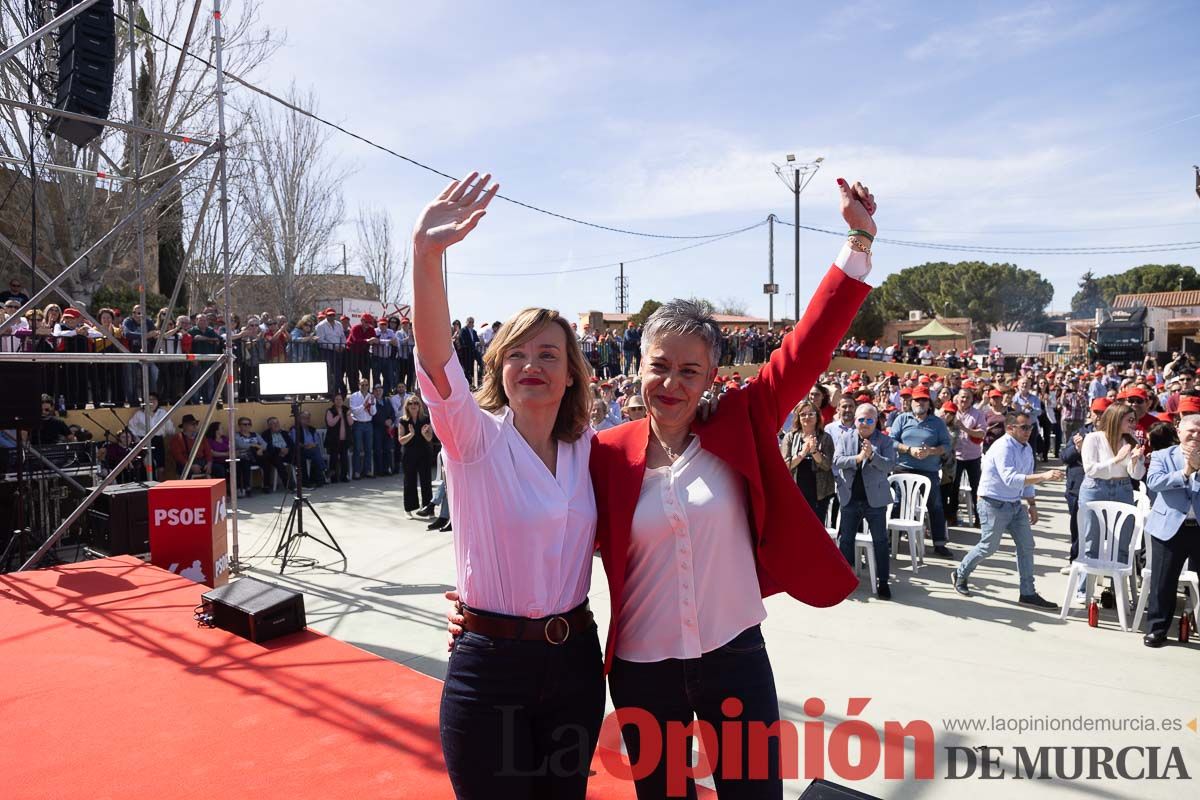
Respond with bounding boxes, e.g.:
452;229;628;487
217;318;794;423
416;353;596;619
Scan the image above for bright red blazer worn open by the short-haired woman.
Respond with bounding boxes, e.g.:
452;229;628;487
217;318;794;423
592;266;870;672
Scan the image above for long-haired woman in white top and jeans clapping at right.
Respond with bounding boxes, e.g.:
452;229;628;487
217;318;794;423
1075;403;1146;602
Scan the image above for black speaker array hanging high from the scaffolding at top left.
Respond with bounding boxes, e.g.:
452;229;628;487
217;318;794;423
48;0;116;148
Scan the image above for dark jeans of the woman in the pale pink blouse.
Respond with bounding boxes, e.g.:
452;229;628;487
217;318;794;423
440;609;605;800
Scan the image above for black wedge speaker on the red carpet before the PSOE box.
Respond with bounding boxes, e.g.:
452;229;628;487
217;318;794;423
200;578;307;642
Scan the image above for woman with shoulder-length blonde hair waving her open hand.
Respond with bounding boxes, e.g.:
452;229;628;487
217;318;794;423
413;173;605;800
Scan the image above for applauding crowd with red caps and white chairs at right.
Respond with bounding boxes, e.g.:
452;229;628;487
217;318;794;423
796;353;1200;646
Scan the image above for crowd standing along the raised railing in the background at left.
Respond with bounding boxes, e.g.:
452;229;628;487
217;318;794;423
0;278;787;411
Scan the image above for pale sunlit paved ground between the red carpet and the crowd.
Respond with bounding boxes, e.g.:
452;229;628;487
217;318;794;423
240;465;1200;800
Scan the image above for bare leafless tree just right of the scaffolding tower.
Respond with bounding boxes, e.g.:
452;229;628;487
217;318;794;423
241;86;348;314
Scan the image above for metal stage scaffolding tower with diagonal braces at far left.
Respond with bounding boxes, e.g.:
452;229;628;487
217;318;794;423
0;0;241;573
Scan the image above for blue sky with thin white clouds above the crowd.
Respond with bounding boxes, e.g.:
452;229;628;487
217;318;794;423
250;0;1200;320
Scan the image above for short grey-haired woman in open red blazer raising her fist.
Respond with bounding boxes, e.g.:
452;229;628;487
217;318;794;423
592;180;876;800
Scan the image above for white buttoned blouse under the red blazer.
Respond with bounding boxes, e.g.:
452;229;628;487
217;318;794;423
616;438;767;662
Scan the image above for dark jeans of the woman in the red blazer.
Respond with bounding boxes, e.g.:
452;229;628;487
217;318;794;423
614;625;784;800
